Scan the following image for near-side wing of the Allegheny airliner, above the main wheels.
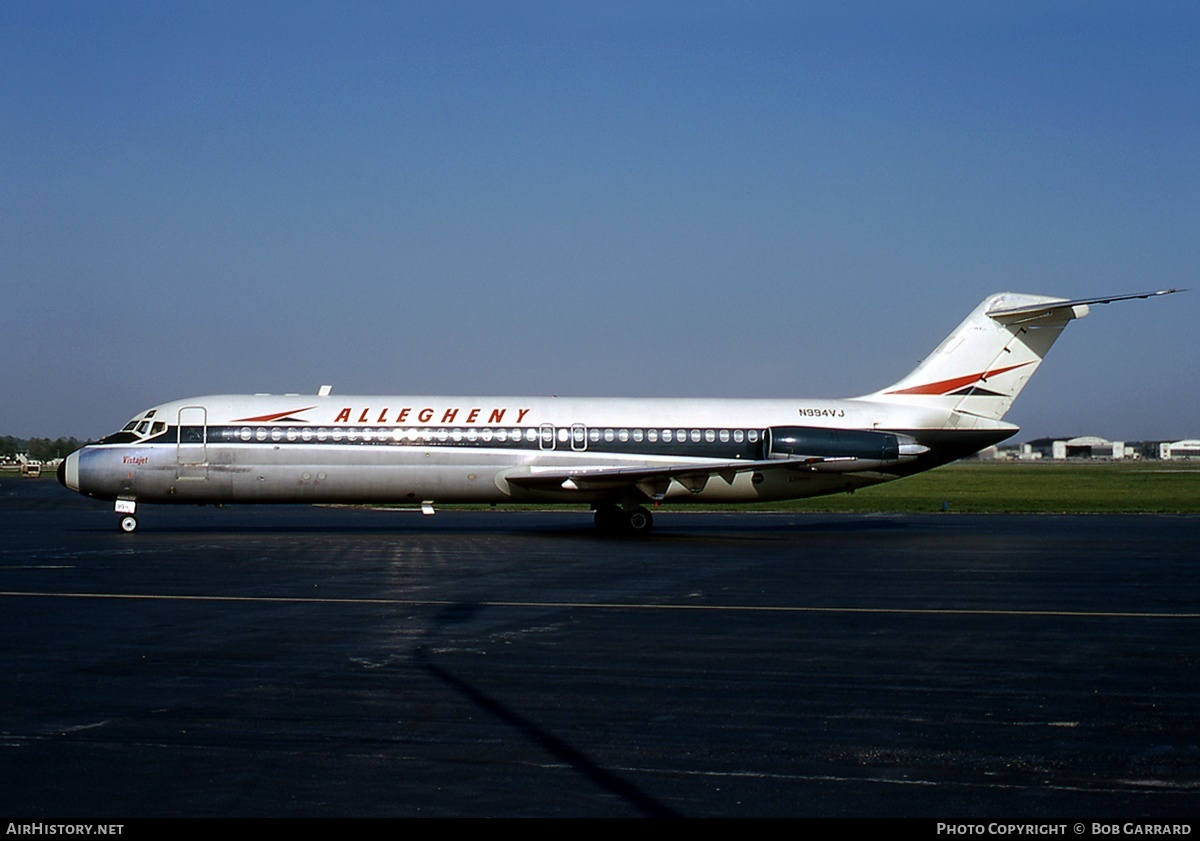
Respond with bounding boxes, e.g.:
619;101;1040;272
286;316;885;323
505;456;840;500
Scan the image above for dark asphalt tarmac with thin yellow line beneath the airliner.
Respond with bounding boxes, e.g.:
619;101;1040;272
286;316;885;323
0;477;1200;822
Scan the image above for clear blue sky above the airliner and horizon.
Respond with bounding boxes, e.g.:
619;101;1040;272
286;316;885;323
0;0;1200;440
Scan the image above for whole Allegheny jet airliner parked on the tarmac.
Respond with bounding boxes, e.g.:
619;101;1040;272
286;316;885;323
58;289;1181;535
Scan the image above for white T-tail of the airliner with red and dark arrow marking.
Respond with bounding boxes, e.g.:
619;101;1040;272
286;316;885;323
864;289;1180;421
